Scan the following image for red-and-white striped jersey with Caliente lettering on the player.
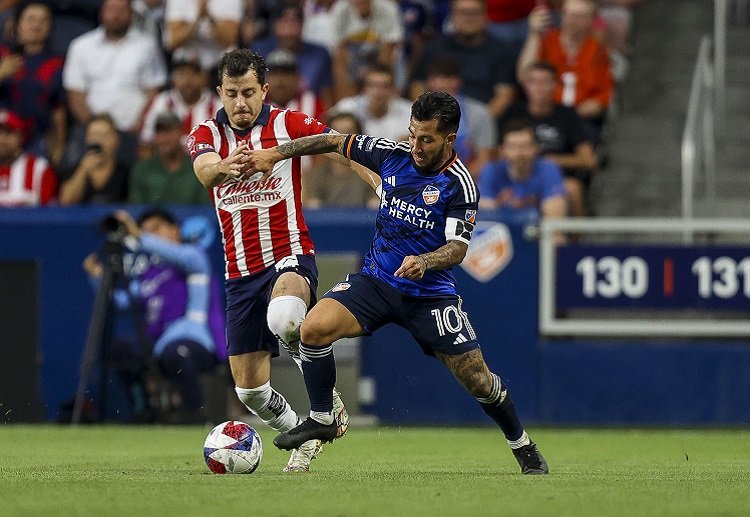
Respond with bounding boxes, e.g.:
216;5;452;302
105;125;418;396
187;104;329;279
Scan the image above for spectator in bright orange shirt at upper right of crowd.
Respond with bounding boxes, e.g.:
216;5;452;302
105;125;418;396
517;0;614;136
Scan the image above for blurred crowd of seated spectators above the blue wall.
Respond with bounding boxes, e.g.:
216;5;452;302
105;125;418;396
0;0;640;216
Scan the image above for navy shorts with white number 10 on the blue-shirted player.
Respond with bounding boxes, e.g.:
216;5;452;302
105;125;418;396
323;273;479;356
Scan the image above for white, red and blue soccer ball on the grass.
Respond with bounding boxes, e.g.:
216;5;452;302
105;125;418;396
203;420;263;474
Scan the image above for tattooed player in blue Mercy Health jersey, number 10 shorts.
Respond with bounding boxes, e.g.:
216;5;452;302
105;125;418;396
248;92;548;474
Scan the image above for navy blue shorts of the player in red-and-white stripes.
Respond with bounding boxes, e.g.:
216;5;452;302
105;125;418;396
226;255;318;357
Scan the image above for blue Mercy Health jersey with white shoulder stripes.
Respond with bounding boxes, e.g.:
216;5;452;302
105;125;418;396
344;135;479;296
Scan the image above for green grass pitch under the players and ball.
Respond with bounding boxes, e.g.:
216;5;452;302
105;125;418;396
0;425;750;517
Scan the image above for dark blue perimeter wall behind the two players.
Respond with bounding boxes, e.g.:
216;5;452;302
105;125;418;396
0;207;750;425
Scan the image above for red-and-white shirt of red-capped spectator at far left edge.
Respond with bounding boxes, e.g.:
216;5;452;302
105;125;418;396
0;153;57;207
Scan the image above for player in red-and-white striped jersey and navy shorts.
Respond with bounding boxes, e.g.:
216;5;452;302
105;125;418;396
187;49;376;471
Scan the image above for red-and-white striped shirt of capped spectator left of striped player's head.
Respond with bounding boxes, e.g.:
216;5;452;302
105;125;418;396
139;88;221;144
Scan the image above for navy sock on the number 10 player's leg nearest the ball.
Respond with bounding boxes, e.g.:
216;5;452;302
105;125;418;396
299;343;336;413
